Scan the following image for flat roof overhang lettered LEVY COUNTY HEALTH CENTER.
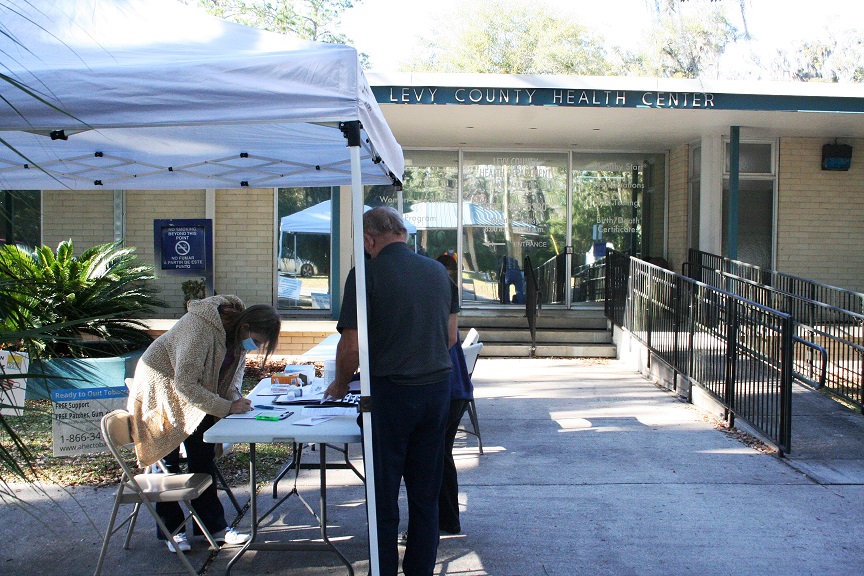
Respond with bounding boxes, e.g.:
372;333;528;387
369;74;864;152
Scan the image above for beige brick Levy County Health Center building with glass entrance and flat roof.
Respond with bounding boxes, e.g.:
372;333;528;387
6;74;864;353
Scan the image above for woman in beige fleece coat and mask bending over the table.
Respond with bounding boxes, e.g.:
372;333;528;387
127;295;281;552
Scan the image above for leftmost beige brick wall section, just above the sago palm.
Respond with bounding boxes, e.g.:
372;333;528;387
42;190;114;250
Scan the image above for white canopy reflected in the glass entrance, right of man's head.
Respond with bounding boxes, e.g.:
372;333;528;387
405;202;540;235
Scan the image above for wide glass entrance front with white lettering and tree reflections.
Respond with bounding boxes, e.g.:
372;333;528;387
403;150;666;307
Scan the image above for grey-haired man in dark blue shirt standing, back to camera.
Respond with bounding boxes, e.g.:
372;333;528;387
326;207;459;576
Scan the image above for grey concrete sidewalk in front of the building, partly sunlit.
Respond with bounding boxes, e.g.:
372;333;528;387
0;358;864;576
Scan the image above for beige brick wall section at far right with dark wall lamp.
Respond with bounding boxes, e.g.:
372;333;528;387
776;138;864;291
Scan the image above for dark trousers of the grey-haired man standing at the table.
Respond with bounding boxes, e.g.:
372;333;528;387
371;376;450;576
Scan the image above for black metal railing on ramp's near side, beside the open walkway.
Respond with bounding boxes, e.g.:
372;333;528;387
605;251;793;452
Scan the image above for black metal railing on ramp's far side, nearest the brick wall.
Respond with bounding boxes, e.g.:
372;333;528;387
688;251;864;411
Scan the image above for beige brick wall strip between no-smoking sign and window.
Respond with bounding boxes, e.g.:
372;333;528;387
214;188;276;305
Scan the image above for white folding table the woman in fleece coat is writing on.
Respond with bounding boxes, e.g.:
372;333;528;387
204;378;362;576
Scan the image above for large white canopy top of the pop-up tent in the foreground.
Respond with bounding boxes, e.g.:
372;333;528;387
0;0;404;190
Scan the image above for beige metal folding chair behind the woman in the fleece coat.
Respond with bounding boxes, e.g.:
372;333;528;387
95;410;219;576
